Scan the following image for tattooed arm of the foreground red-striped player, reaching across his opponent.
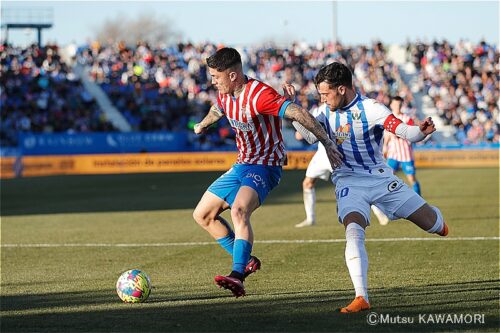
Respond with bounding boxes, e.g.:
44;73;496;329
285;103;342;169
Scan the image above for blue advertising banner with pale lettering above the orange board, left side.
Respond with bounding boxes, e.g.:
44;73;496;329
18;132;190;155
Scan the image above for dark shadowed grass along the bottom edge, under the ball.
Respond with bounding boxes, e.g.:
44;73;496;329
1;280;500;332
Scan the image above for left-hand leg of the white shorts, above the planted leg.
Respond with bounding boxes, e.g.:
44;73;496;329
335;185;370;226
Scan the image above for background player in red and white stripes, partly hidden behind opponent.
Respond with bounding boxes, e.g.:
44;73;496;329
383;96;420;195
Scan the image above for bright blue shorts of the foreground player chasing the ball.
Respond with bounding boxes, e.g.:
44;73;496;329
208;164;282;206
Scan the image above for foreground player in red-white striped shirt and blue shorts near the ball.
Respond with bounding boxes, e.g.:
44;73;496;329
193;48;342;297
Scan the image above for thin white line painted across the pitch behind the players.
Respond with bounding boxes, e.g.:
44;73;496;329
2;237;500;247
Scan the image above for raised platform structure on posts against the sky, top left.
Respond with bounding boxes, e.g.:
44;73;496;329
2;7;53;46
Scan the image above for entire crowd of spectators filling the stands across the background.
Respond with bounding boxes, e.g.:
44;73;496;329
0;41;500;150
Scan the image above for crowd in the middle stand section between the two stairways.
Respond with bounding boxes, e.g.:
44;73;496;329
78;39;414;149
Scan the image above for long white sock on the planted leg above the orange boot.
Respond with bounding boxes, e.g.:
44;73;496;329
345;223;369;303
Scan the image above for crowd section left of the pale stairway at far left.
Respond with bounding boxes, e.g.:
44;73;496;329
0;44;116;146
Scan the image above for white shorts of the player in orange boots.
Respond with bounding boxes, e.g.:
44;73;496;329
335;174;426;224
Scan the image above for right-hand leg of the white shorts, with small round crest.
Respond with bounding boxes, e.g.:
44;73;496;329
372;176;425;220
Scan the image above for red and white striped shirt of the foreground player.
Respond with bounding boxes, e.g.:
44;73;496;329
217;78;287;166
